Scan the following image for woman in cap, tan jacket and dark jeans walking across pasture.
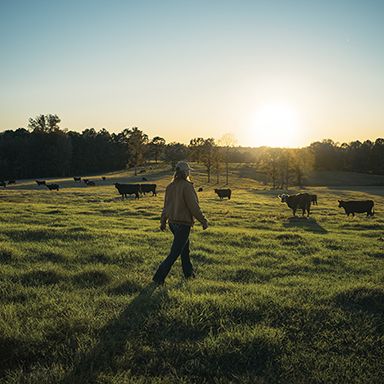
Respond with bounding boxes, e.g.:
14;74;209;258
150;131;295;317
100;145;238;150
153;161;208;284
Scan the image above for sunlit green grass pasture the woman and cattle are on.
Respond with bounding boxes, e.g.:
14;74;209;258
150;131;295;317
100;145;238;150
0;169;384;384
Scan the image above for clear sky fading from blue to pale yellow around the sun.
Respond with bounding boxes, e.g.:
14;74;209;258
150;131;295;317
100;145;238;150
0;0;384;146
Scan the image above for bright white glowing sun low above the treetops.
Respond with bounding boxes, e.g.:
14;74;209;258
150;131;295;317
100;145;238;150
247;103;302;147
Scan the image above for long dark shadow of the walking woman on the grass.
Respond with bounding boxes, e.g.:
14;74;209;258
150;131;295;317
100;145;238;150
60;283;168;384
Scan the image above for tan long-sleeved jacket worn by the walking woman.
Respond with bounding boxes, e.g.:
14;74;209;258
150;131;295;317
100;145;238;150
161;179;207;226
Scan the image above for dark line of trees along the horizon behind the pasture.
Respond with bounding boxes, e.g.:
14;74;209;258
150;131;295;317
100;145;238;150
0;115;384;189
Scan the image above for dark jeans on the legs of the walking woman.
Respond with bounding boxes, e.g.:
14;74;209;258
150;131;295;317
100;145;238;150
153;223;193;283
